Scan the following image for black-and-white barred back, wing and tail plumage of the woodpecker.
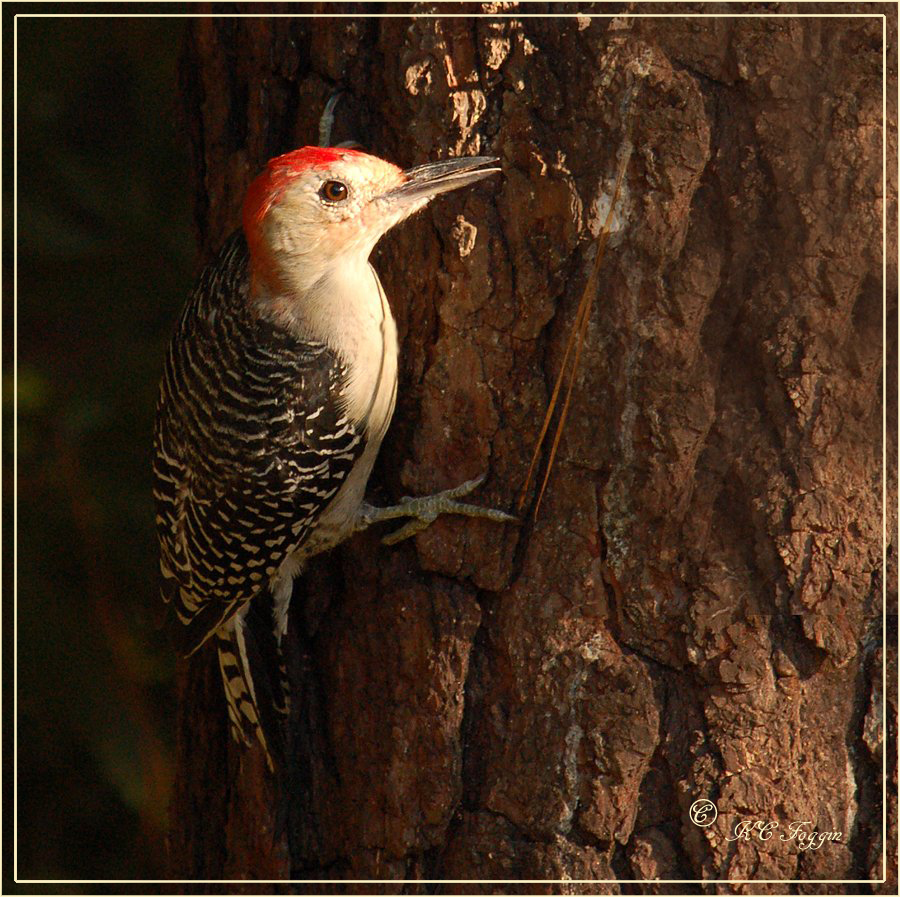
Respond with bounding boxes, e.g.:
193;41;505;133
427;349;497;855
154;233;365;764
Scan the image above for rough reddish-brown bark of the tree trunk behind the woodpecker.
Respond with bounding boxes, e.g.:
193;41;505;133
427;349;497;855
170;4;897;893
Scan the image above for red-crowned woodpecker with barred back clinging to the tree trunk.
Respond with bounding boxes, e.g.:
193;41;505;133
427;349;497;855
154;147;514;768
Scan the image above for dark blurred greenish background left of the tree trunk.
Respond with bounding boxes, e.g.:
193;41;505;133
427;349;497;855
14;16;195;879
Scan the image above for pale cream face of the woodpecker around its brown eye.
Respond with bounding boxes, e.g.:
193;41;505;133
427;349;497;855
262;153;427;268
